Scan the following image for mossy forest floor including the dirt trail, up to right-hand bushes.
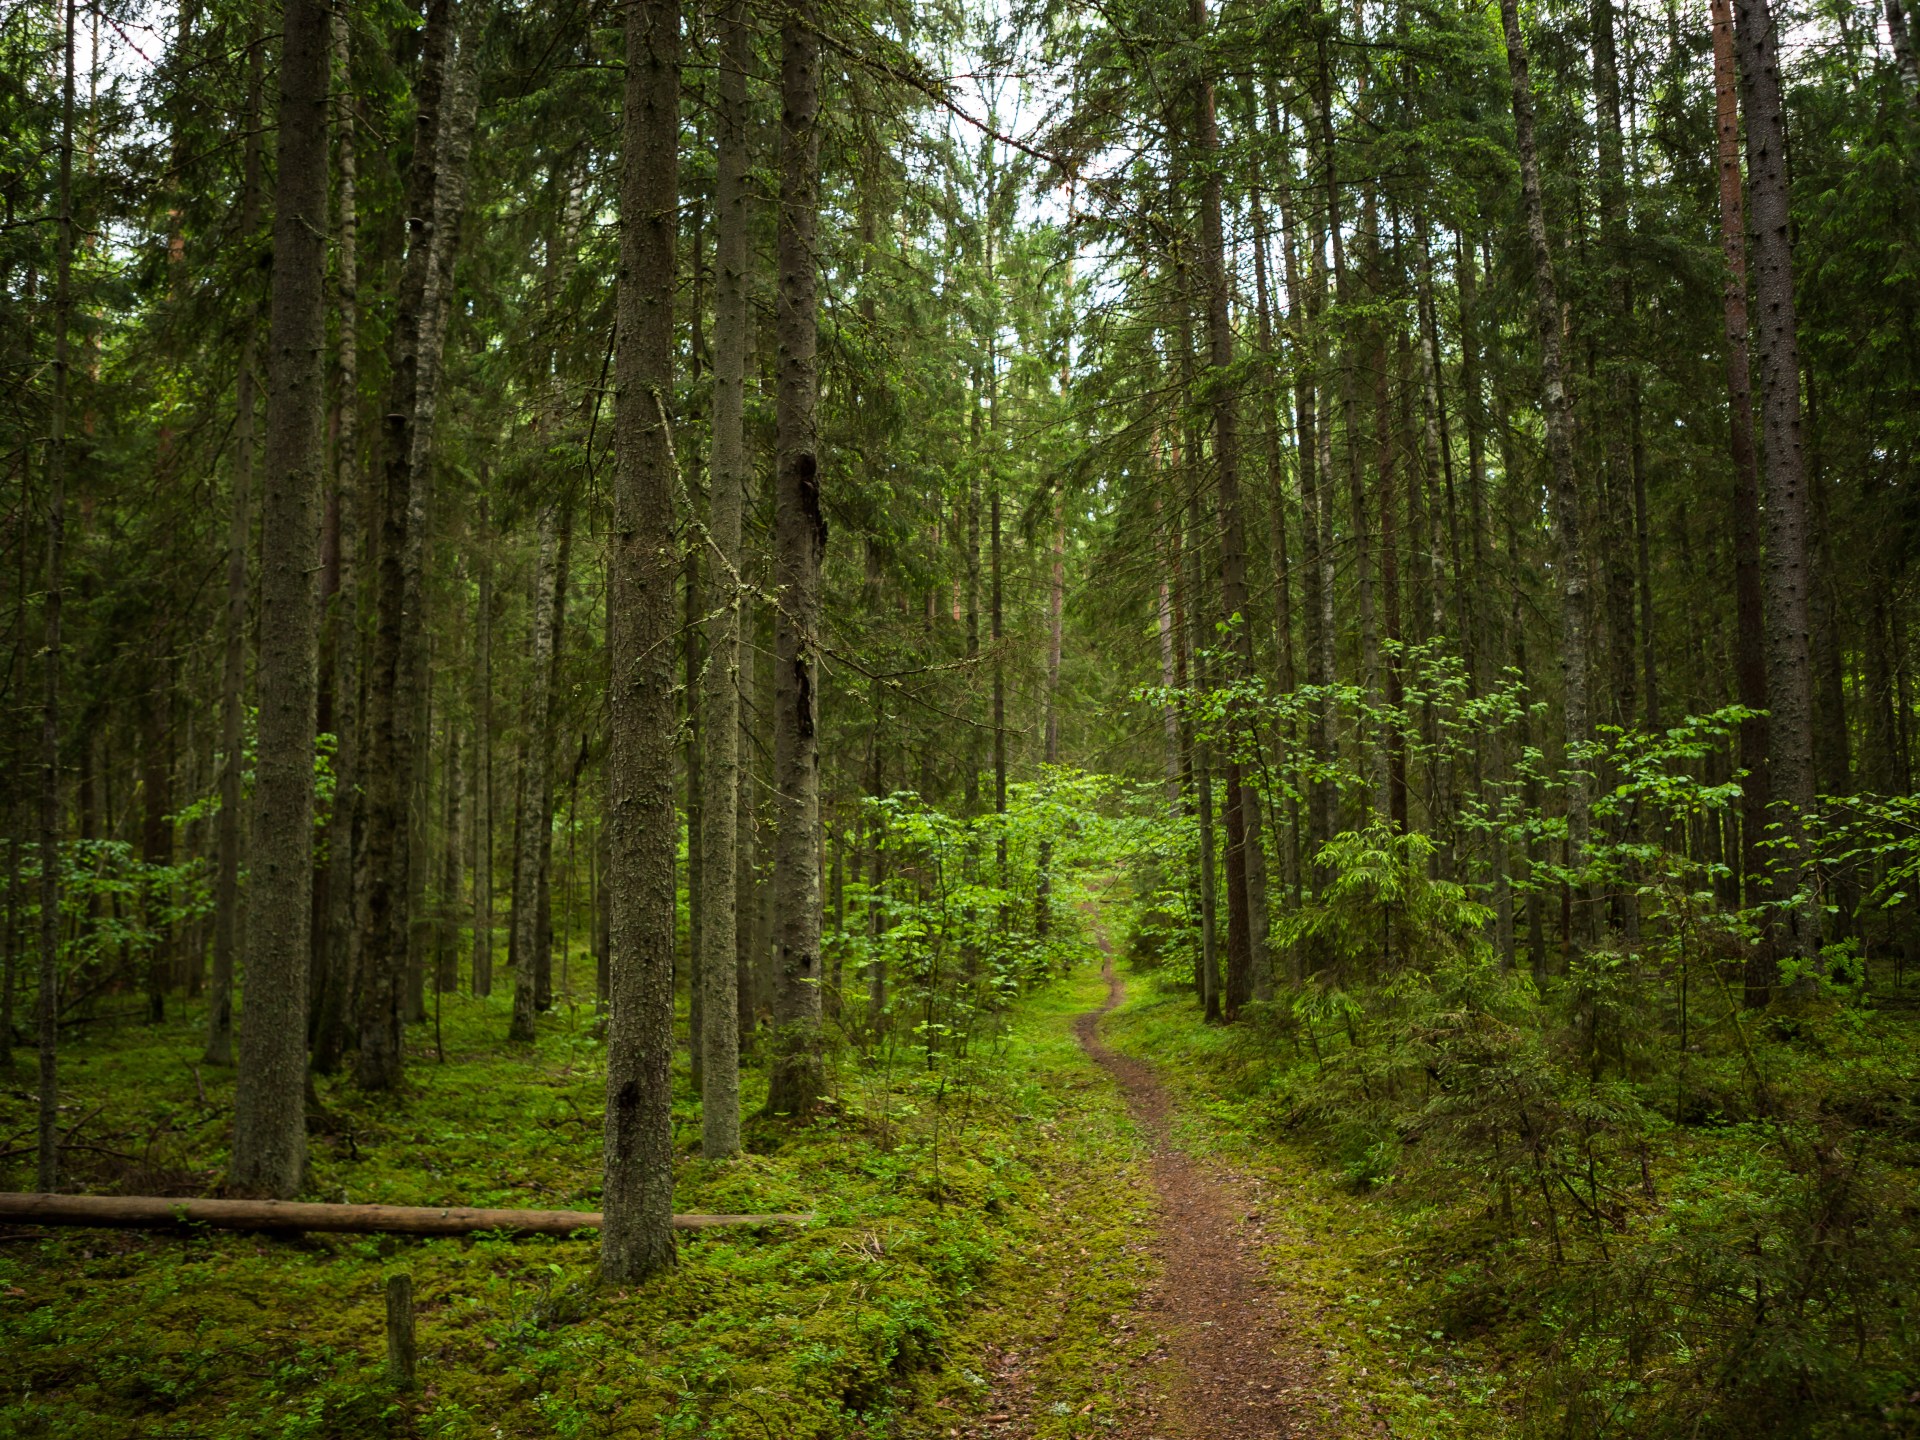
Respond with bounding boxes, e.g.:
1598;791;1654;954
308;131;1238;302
0;929;1498;1440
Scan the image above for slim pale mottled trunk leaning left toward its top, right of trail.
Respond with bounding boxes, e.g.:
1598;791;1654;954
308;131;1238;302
1500;0;1592;935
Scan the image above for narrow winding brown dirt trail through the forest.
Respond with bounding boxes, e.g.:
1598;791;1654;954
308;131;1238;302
1073;947;1323;1440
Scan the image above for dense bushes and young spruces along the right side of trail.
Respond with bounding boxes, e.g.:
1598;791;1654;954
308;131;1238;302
1137;806;1920;1440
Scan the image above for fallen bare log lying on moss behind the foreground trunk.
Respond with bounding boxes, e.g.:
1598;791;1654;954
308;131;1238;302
0;1192;812;1235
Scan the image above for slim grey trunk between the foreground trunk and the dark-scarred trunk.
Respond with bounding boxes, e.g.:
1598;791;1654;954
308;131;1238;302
697;0;753;1160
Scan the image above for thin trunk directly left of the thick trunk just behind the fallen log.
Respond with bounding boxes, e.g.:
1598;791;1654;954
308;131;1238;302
202;21;267;1066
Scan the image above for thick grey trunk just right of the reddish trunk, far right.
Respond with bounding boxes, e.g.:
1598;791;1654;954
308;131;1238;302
1734;0;1820;1000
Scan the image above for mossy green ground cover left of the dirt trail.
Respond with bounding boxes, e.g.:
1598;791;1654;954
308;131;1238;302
0;964;1150;1440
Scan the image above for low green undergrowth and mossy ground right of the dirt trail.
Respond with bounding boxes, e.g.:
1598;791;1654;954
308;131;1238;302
1108;977;1920;1440
